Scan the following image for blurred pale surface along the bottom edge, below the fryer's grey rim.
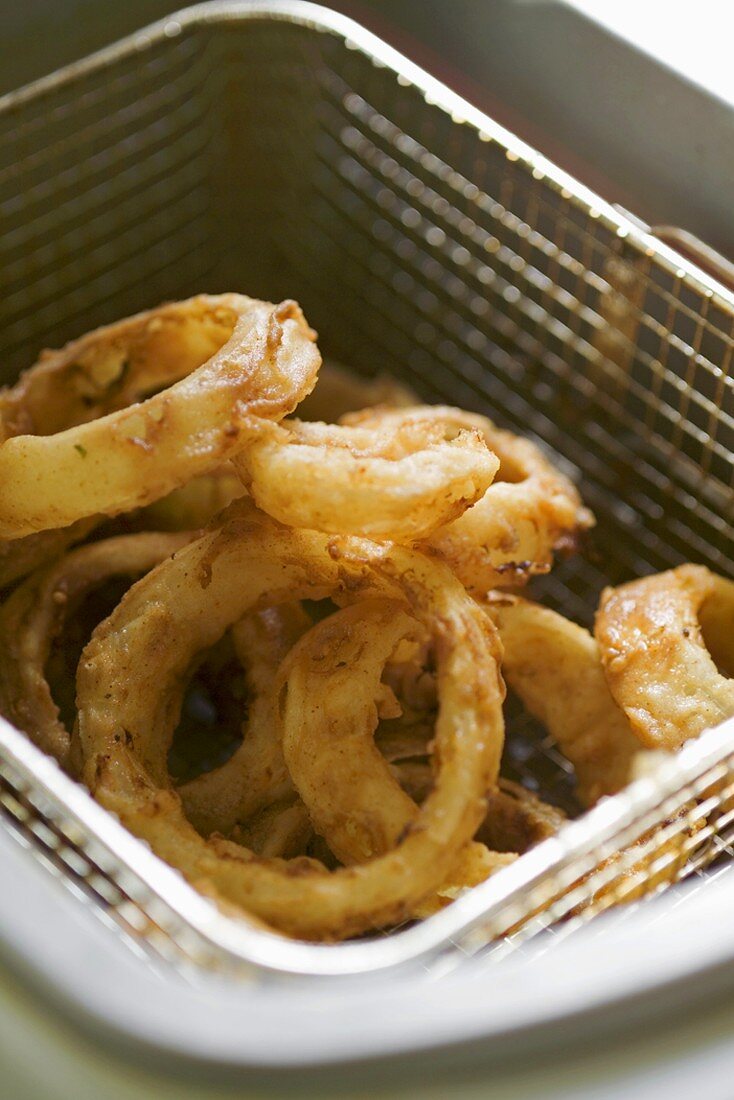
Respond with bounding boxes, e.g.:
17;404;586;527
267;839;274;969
0;975;734;1100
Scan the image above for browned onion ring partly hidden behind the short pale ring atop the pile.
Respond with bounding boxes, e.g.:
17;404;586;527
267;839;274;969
343;406;593;595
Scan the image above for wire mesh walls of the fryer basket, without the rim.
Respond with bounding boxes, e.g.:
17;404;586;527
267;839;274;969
0;6;734;976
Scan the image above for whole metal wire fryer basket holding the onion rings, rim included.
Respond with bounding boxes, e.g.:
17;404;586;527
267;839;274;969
0;3;734;974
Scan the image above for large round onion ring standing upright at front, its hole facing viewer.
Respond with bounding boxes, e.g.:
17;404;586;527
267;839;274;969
77;502;503;938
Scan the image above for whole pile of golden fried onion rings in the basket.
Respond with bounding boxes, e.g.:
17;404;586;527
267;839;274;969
0;294;734;941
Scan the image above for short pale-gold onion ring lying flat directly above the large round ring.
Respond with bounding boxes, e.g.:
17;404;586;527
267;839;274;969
233;410;500;542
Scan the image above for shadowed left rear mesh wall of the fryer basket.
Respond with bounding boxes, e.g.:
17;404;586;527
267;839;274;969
0;27;217;378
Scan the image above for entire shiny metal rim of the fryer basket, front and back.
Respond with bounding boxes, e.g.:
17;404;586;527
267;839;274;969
0;0;734;976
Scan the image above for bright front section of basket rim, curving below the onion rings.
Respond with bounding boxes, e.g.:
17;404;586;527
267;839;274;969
0;699;734;977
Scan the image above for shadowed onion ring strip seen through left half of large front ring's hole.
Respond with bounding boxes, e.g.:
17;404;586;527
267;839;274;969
178;602;311;831
